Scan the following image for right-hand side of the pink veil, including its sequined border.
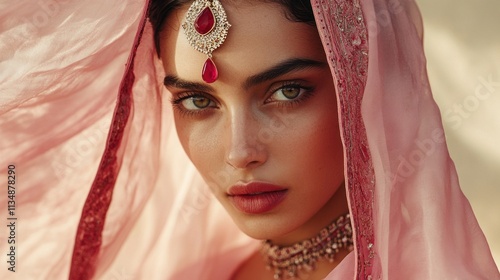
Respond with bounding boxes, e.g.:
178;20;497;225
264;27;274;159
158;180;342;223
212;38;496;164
313;0;500;279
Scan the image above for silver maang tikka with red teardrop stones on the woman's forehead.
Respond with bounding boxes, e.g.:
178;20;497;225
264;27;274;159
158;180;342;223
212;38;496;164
182;0;231;83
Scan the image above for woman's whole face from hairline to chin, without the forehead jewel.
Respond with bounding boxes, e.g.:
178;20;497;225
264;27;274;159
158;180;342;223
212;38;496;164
160;1;347;243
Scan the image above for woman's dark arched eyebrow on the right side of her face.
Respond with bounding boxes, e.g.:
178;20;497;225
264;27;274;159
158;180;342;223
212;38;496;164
244;58;328;88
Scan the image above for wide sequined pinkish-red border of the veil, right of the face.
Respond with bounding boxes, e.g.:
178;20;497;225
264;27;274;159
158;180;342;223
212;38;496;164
313;0;378;279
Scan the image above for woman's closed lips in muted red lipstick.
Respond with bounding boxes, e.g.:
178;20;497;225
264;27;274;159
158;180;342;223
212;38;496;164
227;182;287;214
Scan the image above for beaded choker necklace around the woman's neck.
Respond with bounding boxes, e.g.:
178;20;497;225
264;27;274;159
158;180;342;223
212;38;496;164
262;213;353;280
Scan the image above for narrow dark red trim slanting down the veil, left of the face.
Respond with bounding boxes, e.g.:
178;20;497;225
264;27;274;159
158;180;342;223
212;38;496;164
69;3;149;280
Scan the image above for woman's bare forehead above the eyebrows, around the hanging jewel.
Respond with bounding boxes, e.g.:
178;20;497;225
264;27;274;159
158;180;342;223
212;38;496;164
160;1;325;85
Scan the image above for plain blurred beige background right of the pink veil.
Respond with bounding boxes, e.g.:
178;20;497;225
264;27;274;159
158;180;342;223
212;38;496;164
417;0;500;266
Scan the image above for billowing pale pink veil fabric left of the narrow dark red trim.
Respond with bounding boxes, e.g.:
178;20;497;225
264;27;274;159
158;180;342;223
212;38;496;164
0;0;147;279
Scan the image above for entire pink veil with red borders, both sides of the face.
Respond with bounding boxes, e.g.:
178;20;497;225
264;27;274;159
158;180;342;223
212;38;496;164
0;0;500;280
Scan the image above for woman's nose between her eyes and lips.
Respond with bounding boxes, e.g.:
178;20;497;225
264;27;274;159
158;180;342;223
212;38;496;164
226;111;268;169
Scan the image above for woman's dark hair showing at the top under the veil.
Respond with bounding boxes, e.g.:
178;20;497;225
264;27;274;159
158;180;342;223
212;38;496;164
149;0;316;53
